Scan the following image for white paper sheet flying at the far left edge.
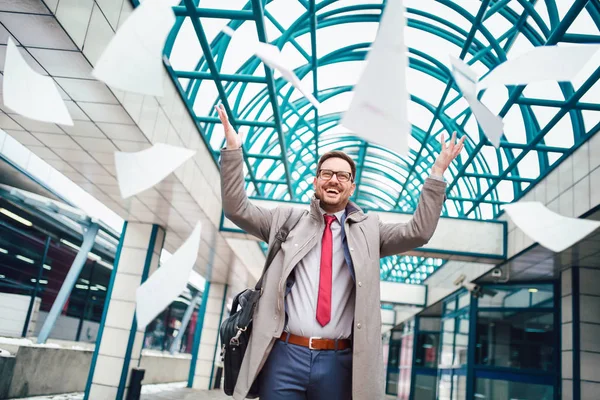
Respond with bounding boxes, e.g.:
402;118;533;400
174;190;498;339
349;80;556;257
2;37;73;126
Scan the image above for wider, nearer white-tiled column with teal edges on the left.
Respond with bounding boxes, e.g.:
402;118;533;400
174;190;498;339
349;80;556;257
85;222;165;400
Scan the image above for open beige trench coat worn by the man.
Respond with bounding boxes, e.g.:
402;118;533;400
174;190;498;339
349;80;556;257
221;149;446;400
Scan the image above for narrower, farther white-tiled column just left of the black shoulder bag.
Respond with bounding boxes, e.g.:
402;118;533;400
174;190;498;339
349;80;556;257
188;281;228;389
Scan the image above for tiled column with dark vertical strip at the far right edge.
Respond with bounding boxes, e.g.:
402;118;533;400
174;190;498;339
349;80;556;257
561;267;600;400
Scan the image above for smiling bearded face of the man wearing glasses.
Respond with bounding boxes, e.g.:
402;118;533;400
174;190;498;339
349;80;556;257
313;157;356;212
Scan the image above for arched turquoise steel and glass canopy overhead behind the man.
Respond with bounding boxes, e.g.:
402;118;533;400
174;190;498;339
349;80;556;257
164;0;600;284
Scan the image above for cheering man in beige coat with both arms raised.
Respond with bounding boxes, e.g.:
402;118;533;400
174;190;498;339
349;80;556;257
217;106;464;400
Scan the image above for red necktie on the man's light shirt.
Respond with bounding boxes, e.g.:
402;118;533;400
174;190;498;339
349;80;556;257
317;215;335;326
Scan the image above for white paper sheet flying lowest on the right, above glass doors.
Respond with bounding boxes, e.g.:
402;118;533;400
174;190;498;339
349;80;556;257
504;201;600;253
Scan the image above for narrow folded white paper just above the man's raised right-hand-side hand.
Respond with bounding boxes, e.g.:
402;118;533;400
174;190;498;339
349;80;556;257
450;57;504;148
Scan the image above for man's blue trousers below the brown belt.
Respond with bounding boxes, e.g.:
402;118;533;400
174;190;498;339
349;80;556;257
258;340;352;400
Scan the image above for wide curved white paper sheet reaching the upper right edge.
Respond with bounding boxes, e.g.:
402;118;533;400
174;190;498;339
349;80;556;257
477;44;600;90
